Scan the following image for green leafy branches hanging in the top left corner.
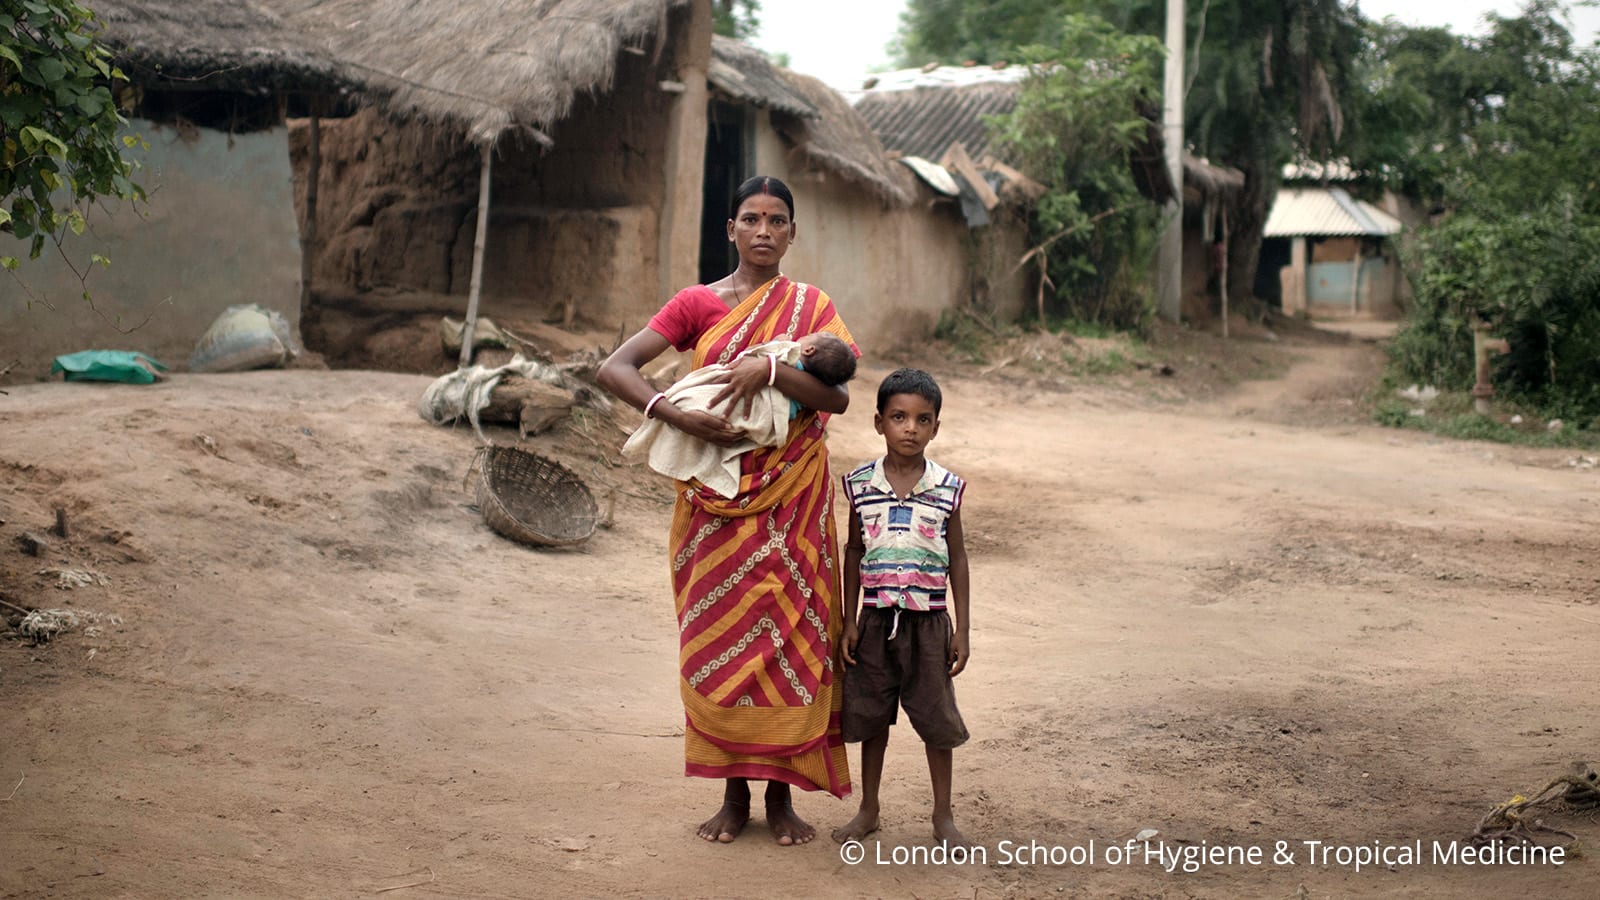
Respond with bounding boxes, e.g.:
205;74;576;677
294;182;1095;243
0;0;144;269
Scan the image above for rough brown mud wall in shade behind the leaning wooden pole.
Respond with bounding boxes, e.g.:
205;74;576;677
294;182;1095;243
294;10;709;327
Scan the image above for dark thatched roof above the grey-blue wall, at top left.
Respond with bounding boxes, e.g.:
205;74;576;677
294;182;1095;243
88;0;342;93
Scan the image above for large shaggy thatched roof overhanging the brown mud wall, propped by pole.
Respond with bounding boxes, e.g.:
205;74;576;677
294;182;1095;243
262;0;688;143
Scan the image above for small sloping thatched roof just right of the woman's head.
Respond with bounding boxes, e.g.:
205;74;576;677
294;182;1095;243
773;69;915;207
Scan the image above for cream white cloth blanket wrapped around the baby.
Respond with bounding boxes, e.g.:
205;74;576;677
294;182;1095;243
622;341;800;498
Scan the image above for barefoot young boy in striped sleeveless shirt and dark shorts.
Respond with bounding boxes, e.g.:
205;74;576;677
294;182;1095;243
834;368;971;846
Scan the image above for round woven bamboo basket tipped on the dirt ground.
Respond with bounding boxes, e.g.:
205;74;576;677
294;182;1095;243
478;447;600;546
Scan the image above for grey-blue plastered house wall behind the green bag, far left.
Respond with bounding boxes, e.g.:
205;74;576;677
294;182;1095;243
0;119;299;383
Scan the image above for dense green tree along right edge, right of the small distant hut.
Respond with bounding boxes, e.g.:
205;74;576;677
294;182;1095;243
1357;0;1600;423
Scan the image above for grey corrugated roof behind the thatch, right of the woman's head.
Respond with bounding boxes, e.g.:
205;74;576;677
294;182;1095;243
856;80;1018;162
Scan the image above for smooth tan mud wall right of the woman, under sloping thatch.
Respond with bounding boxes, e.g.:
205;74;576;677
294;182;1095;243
755;115;1027;352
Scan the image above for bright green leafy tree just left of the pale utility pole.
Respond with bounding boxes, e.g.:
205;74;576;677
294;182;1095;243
990;16;1162;328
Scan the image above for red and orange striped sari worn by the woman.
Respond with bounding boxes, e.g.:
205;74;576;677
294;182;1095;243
669;275;854;798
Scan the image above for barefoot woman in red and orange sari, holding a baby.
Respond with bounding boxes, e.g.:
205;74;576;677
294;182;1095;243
600;176;859;846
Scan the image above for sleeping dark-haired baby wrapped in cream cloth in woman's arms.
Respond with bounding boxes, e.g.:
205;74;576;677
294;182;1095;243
622;331;856;496
